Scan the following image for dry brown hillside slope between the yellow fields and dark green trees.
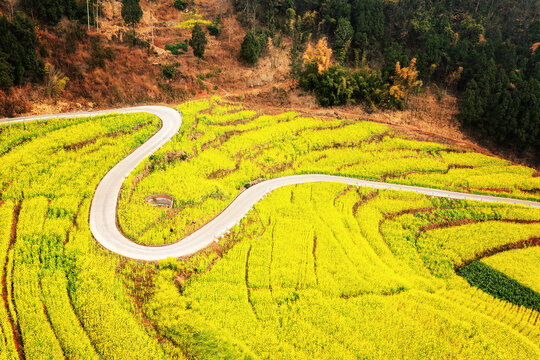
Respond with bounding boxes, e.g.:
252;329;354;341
0;0;540;168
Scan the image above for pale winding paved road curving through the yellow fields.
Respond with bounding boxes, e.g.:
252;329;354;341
0;106;540;261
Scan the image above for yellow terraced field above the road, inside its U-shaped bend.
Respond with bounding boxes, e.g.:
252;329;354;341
118;98;540;245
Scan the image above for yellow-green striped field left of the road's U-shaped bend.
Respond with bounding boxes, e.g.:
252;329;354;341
0;114;173;359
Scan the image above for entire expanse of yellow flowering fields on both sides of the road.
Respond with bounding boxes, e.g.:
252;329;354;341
0;98;540;359
